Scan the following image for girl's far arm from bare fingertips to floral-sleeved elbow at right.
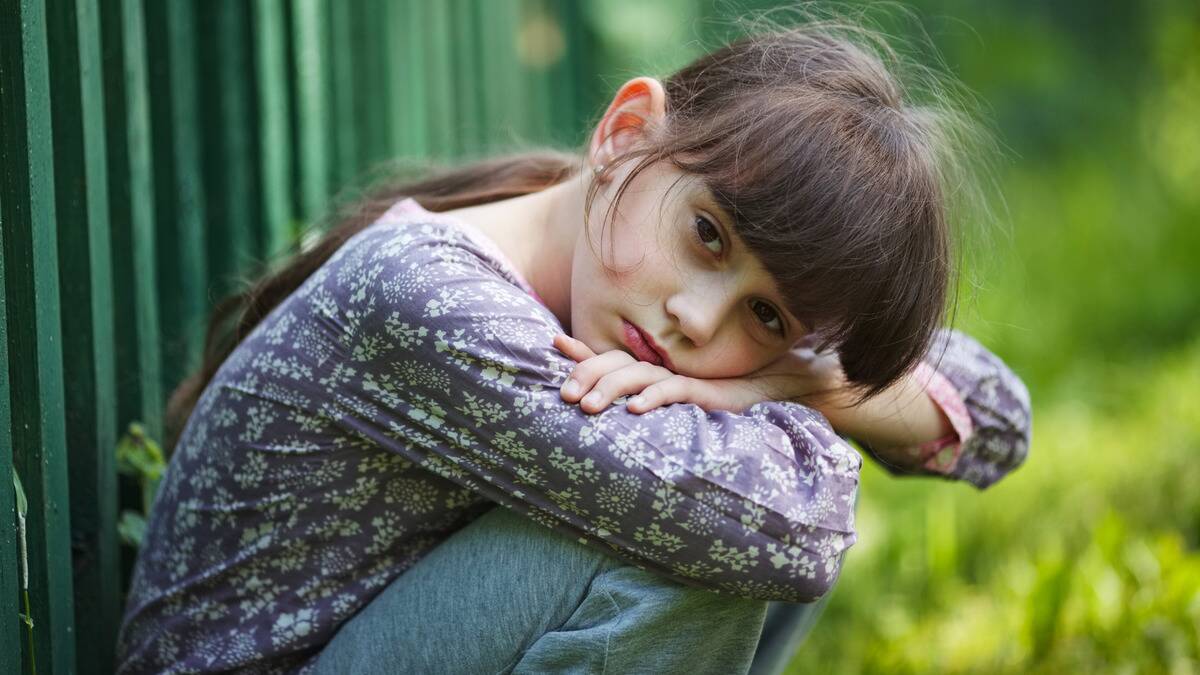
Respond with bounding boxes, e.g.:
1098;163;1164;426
556;321;1030;488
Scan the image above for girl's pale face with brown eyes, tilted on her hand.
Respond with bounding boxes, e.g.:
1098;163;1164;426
571;162;808;378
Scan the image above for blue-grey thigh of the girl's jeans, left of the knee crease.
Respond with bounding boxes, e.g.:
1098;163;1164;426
314;507;612;675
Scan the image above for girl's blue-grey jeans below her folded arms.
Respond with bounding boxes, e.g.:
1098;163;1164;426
316;507;829;675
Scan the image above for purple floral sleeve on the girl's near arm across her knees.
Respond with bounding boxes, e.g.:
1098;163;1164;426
324;219;862;602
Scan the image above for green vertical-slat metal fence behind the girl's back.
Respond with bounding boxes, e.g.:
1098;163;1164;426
0;0;602;673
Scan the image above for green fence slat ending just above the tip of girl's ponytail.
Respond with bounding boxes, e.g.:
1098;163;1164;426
145;0;208;392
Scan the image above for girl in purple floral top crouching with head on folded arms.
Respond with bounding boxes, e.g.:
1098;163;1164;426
119;25;1030;673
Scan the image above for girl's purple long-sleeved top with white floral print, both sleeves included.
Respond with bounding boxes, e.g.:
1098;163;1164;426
119;199;1030;673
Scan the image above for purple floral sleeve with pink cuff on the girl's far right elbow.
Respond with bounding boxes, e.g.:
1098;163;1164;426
864;329;1032;489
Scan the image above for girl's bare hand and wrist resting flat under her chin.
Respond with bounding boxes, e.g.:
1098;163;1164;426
554;334;815;414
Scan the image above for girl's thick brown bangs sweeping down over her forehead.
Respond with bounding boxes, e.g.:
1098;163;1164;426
664;90;949;394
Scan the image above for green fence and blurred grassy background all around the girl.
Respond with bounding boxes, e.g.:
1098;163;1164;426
0;0;1200;673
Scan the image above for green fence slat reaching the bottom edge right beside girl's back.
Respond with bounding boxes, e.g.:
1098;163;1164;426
47;0;120;673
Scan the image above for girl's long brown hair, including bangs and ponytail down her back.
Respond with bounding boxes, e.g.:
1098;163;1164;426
167;22;993;444
